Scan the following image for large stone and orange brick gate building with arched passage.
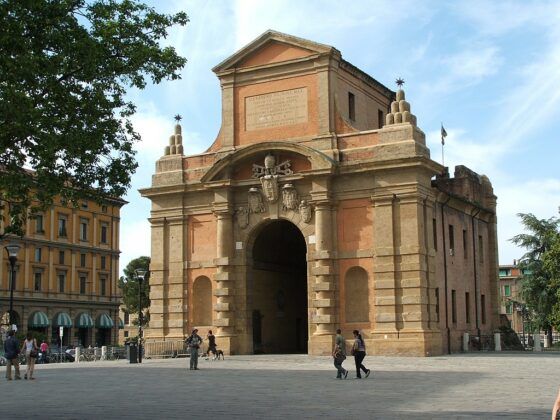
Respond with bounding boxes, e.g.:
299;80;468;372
141;31;498;356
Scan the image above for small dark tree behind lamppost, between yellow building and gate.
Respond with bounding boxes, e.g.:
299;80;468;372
119;256;150;319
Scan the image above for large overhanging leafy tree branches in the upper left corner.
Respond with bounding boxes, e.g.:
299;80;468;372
0;0;188;236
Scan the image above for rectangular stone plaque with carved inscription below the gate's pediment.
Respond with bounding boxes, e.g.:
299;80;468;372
245;88;307;131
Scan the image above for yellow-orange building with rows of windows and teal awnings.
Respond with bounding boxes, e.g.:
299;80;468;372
0;198;126;346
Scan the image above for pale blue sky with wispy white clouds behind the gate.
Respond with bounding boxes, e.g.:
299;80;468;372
120;0;560;272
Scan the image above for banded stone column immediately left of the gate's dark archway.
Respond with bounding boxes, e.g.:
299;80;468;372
214;205;236;354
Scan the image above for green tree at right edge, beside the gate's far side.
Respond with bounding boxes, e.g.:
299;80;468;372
511;213;560;342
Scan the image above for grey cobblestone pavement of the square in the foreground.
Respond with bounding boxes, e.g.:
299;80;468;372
0;353;560;419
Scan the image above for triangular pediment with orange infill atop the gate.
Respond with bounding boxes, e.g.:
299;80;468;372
212;30;340;73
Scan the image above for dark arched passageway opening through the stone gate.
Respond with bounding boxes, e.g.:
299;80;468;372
247;220;308;353
